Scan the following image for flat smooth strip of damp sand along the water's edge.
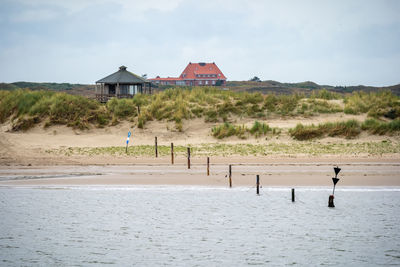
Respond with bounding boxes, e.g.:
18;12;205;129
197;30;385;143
0;159;400;187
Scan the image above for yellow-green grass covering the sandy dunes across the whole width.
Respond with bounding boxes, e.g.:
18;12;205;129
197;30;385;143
0;87;400;140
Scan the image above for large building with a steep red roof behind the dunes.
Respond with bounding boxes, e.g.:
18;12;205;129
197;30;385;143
149;62;226;86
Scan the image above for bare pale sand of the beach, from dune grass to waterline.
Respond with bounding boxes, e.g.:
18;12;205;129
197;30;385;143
0;119;400;186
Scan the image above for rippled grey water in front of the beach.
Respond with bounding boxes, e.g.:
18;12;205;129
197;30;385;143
0;187;400;266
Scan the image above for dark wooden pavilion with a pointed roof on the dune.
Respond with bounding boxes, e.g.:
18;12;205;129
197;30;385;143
95;66;151;102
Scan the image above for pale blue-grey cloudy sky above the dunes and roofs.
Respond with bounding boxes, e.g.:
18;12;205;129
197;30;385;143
0;0;400;86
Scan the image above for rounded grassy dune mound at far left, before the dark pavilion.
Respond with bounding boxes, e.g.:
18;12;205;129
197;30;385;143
0;90;110;130
